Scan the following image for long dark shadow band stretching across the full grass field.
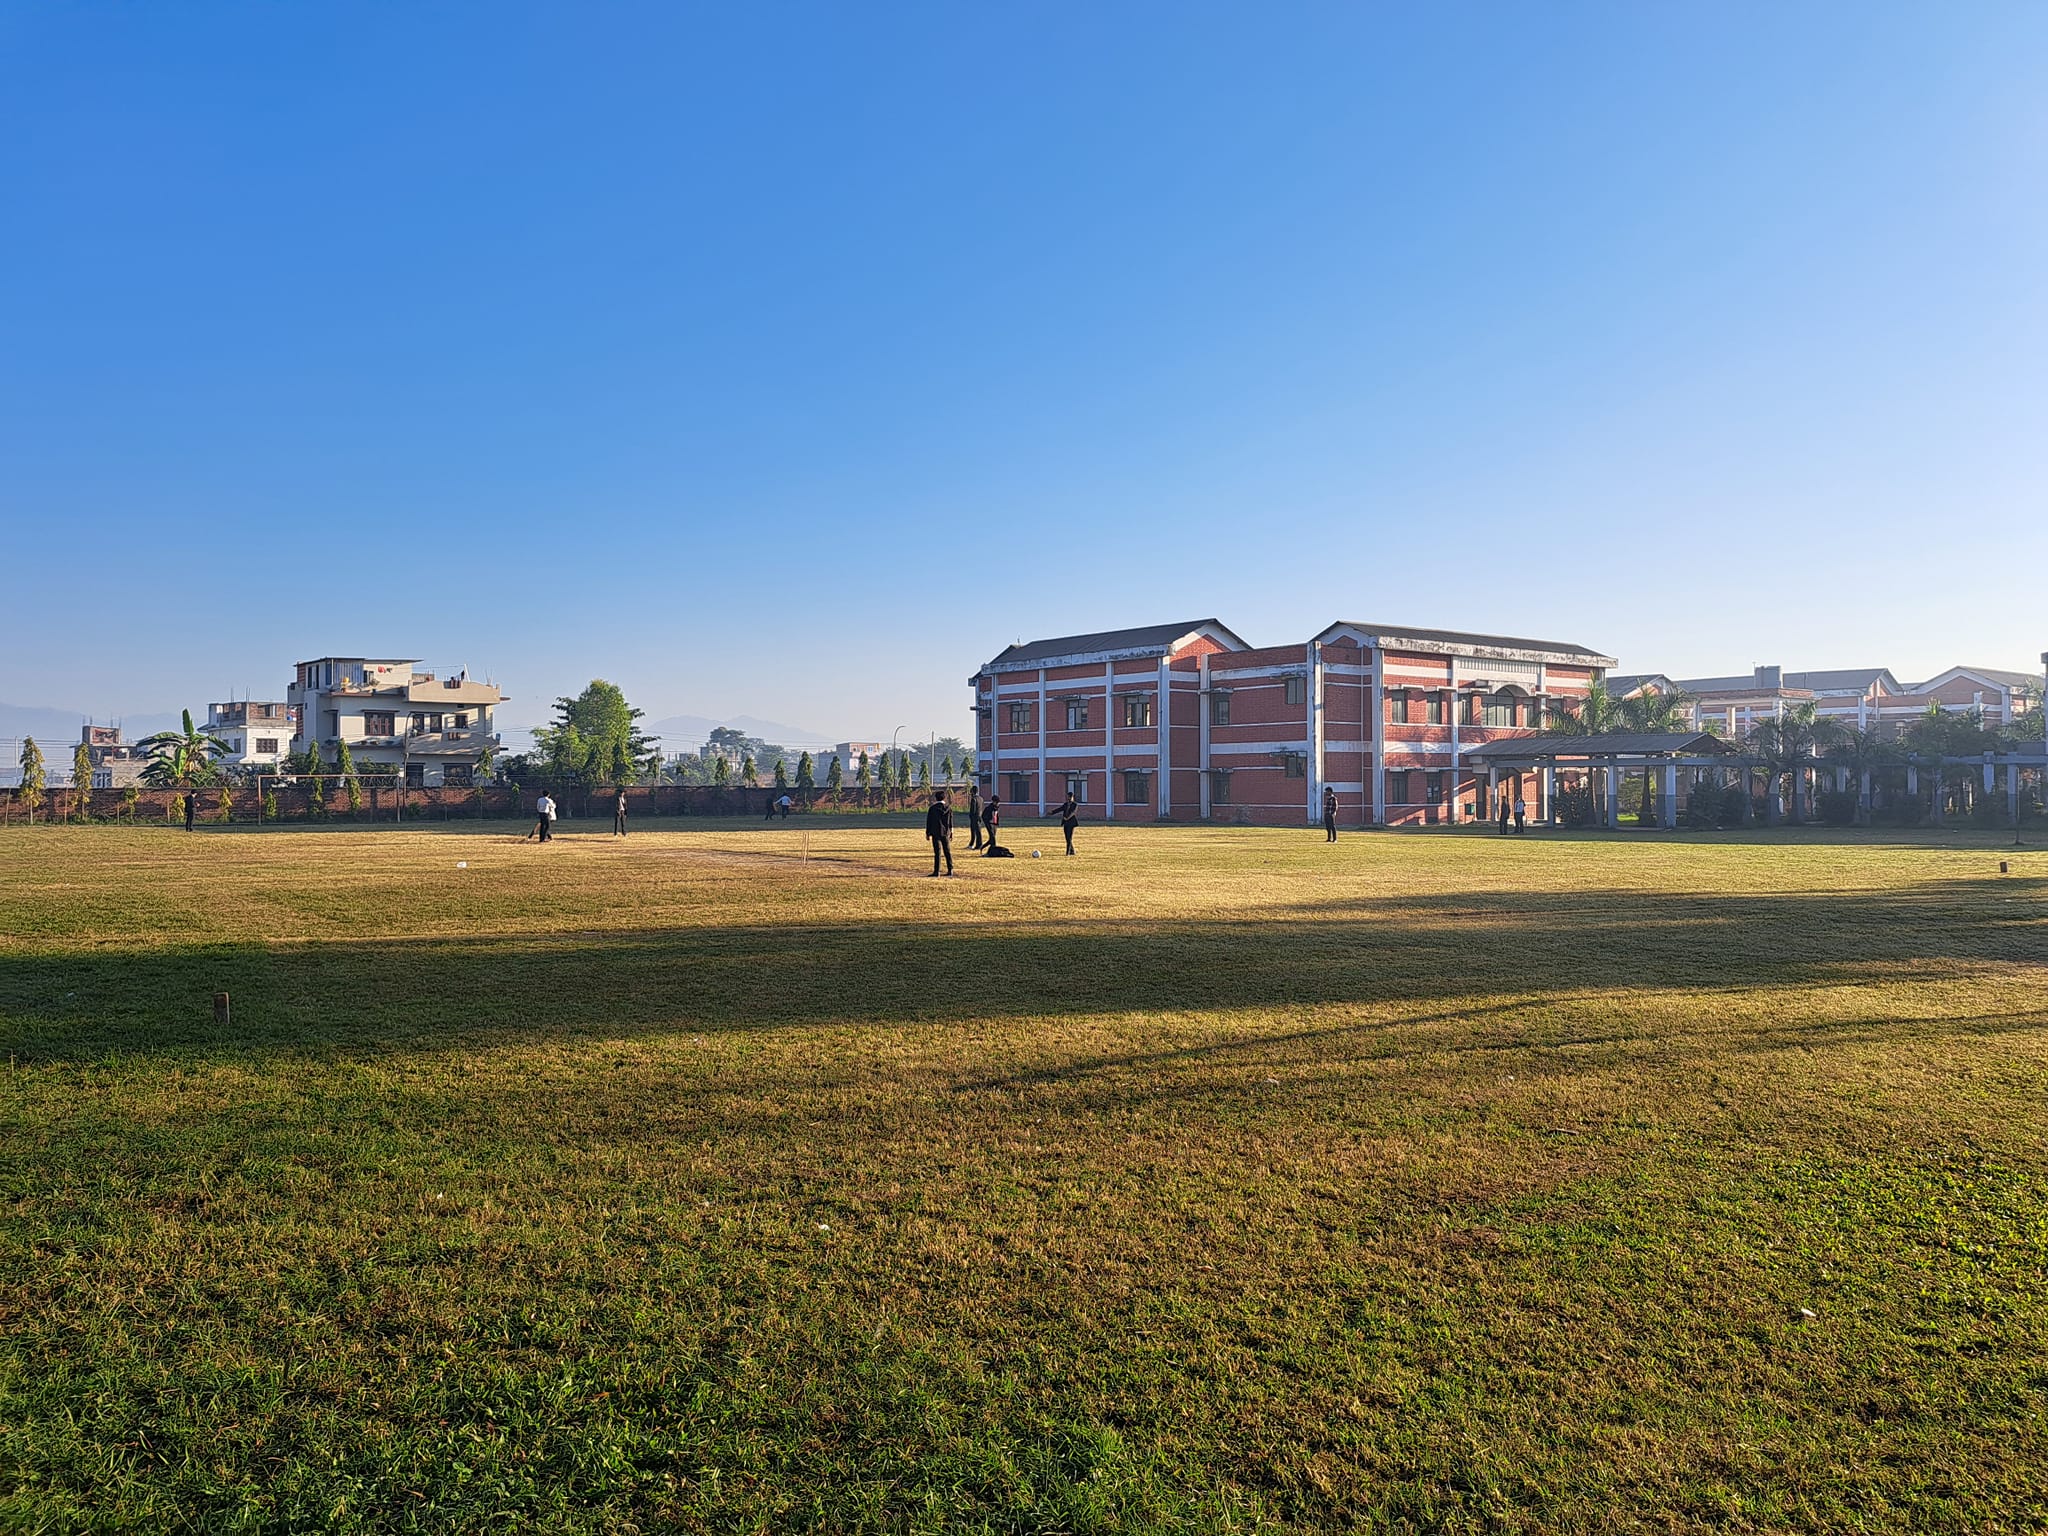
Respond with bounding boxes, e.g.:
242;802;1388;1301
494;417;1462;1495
0;877;2048;1061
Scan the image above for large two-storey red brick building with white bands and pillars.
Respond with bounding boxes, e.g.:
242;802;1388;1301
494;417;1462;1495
969;618;1614;825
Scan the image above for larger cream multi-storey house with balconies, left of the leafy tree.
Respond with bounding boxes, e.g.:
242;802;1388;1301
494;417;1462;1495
285;655;504;788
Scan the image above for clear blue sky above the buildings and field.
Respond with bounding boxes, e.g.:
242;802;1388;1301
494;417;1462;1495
0;0;2048;735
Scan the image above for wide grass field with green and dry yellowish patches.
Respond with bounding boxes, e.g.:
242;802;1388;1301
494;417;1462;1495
0;819;2048;1532
